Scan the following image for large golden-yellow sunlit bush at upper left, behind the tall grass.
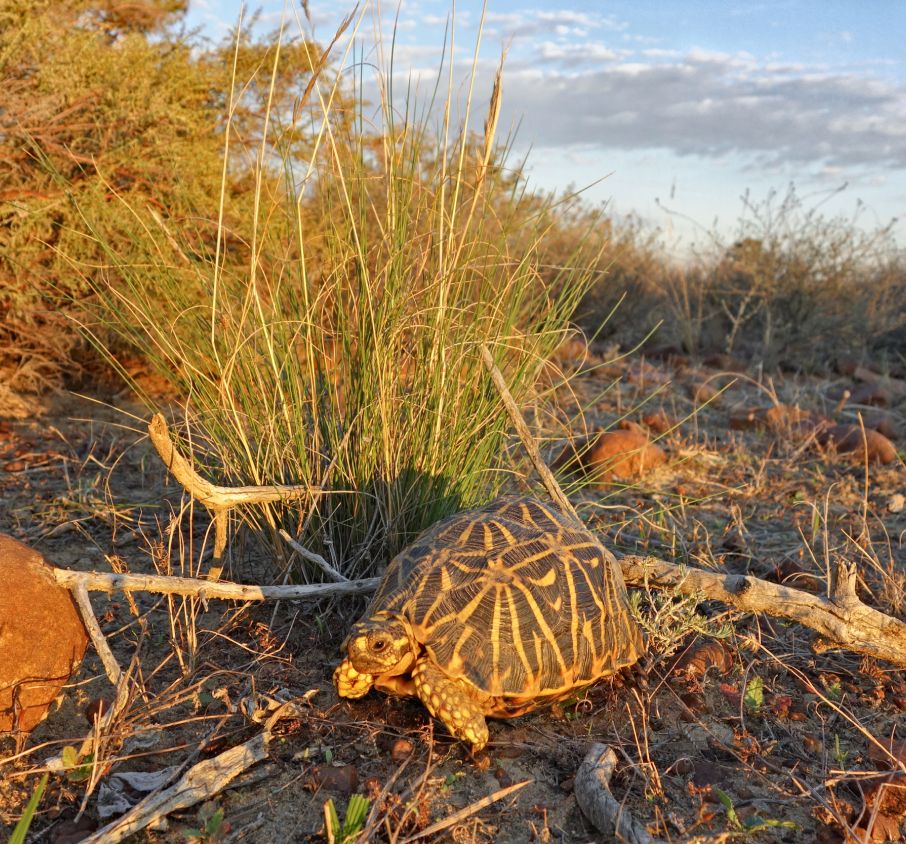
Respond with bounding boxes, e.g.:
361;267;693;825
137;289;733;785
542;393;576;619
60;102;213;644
0;0;332;382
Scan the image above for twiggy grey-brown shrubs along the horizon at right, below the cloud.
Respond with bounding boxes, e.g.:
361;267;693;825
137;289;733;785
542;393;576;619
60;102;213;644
558;188;906;371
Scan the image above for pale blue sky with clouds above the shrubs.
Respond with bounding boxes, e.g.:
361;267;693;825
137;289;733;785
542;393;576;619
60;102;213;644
190;0;906;248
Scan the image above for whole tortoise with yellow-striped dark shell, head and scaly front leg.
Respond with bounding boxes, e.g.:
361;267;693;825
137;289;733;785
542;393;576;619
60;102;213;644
334;496;644;752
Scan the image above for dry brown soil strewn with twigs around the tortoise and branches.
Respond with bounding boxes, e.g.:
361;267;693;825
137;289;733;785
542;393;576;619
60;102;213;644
0;355;906;844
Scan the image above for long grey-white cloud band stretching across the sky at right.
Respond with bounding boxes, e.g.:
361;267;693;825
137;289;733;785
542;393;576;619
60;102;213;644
494;49;906;168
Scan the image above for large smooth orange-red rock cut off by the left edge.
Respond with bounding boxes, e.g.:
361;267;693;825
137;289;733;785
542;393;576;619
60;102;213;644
0;534;88;732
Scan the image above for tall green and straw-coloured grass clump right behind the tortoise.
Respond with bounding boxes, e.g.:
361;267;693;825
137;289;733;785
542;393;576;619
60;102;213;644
74;9;588;576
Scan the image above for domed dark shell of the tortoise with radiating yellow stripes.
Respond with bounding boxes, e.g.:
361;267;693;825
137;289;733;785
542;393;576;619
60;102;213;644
366;496;644;714
